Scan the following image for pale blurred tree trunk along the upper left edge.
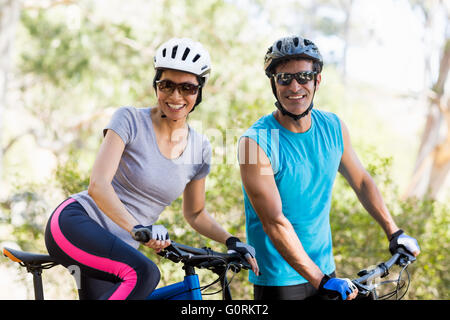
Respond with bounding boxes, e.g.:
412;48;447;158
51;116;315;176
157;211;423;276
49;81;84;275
0;0;20;181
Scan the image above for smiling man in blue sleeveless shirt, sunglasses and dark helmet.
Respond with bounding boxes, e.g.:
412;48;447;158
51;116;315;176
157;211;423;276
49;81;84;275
239;36;420;300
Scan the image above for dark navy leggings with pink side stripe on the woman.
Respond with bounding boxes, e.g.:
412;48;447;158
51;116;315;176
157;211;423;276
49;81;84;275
45;198;160;300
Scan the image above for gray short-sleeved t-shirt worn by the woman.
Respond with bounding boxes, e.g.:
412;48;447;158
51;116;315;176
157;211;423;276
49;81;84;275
71;107;211;248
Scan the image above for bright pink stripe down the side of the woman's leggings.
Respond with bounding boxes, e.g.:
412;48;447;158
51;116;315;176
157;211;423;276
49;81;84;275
50;198;137;300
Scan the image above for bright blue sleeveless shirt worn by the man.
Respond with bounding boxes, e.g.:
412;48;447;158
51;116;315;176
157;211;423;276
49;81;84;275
242;109;344;286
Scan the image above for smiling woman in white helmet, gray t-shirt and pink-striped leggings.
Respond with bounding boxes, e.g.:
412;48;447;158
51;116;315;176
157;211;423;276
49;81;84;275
45;38;258;299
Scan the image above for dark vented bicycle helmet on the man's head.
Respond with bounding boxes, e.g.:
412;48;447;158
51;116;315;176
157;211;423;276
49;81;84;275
264;36;323;78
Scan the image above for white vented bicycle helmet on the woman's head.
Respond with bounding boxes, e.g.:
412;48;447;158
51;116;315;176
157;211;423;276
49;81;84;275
154;38;211;83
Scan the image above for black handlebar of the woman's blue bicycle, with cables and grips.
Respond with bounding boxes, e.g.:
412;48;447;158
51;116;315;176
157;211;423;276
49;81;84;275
158;241;251;272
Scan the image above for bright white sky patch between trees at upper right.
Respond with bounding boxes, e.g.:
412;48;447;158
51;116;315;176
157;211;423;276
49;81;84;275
312;0;448;93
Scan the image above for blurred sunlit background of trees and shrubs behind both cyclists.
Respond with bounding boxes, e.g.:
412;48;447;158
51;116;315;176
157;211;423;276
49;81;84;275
0;0;450;299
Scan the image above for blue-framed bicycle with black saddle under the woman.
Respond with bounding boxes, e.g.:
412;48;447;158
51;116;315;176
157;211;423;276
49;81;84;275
3;241;251;300
